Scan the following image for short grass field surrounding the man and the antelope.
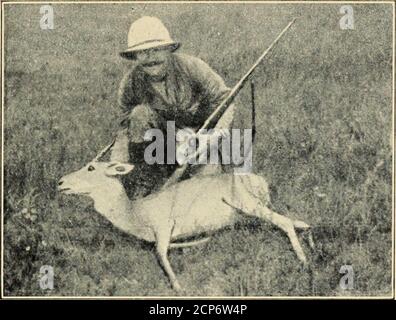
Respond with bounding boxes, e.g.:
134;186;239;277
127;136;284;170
4;4;392;296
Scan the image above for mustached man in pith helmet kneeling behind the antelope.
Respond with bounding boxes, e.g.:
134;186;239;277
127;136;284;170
110;17;237;197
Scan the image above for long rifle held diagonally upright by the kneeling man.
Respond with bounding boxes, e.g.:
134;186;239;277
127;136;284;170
162;18;296;189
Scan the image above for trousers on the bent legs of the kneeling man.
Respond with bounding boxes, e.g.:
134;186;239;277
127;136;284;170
110;104;234;198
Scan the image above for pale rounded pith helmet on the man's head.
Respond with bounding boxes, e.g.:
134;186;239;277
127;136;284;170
120;17;180;59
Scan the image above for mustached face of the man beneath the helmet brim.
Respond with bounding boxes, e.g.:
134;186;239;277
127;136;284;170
136;48;171;79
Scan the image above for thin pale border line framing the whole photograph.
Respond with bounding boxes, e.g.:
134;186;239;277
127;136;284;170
0;0;396;301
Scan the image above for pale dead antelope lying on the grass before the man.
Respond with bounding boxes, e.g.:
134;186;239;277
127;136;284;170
58;146;313;291
